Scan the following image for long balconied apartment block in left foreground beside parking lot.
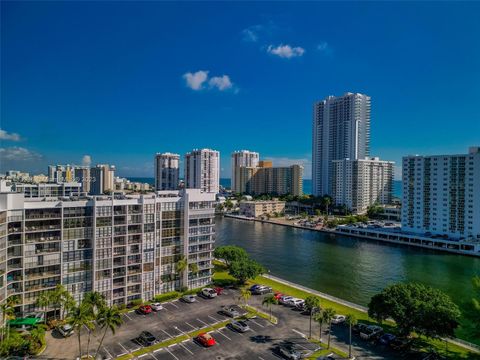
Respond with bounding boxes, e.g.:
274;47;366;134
0;189;215;312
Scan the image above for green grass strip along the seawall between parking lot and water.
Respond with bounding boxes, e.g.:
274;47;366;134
213;262;480;360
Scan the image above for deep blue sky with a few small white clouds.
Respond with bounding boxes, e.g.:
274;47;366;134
0;2;480;177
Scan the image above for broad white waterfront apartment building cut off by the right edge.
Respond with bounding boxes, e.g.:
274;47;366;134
402;147;480;239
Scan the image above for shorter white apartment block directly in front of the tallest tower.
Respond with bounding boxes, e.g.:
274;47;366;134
332;157;394;214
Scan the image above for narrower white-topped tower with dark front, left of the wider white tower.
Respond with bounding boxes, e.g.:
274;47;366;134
155;152;180;191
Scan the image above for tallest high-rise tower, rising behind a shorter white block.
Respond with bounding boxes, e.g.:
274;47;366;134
312;93;370;196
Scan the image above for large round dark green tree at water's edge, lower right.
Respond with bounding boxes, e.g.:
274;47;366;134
368;283;460;338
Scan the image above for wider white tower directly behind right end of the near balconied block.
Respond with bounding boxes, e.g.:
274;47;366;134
185;149;220;194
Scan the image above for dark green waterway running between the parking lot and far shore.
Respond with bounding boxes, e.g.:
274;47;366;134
217;218;480;344
